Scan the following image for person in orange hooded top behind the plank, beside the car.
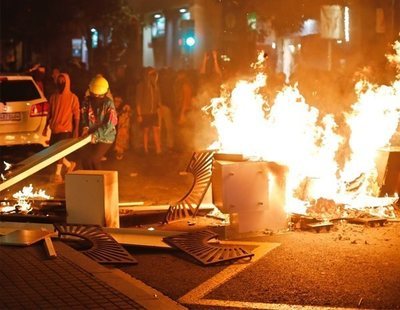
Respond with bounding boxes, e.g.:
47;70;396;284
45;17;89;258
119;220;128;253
42;73;80;183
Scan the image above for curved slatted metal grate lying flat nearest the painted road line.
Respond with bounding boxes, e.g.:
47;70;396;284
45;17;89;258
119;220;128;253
163;230;254;265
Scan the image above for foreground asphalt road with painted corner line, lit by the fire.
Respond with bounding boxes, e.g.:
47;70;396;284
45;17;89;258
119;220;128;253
114;223;400;309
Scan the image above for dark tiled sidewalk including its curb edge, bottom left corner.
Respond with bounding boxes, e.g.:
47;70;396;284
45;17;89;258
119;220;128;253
0;237;184;309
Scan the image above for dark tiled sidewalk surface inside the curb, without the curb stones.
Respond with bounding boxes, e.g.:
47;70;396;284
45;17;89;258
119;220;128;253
0;243;143;309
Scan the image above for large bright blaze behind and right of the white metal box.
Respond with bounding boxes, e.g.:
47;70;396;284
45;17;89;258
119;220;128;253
206;42;400;217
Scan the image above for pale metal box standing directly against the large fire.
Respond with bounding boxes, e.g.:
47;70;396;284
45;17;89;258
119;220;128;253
212;161;287;233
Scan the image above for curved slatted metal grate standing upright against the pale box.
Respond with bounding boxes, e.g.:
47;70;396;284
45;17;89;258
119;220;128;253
164;151;214;223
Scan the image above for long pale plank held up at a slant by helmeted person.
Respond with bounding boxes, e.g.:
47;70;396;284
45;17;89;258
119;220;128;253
0;135;91;192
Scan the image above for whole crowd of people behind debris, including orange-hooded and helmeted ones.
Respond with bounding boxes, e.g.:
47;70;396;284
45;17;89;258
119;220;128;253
29;50;222;183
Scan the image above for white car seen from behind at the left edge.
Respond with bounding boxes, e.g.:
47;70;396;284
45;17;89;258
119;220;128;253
0;75;50;147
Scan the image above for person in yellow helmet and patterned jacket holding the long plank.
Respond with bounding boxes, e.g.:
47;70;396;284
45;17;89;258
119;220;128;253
81;75;118;170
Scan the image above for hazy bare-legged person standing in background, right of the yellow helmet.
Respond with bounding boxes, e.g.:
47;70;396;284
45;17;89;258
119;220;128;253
136;67;161;154
